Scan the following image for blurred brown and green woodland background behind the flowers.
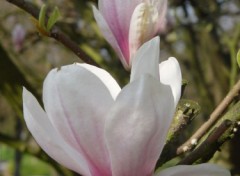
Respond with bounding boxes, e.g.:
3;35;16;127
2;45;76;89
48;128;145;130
0;0;240;176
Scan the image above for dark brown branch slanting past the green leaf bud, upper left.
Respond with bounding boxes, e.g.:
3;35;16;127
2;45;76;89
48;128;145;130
6;0;100;67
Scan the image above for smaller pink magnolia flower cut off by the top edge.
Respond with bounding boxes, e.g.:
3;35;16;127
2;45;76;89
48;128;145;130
93;0;167;69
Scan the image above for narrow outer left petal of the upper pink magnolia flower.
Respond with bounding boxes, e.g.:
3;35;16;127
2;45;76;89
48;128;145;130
92;6;129;69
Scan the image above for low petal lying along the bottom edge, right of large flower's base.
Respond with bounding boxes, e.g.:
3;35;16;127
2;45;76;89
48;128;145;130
155;164;231;176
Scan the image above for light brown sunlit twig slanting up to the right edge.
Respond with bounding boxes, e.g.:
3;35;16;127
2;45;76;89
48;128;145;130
177;80;240;155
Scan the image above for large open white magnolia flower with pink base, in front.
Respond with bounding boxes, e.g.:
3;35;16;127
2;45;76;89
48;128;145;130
23;37;230;176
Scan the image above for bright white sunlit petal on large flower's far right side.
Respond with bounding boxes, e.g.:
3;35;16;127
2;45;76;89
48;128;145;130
159;57;182;106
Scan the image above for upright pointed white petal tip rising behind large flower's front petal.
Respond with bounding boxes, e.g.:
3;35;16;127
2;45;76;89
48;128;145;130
130;37;160;82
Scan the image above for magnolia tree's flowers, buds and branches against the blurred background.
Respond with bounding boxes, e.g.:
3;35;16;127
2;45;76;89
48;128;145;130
1;0;240;176
